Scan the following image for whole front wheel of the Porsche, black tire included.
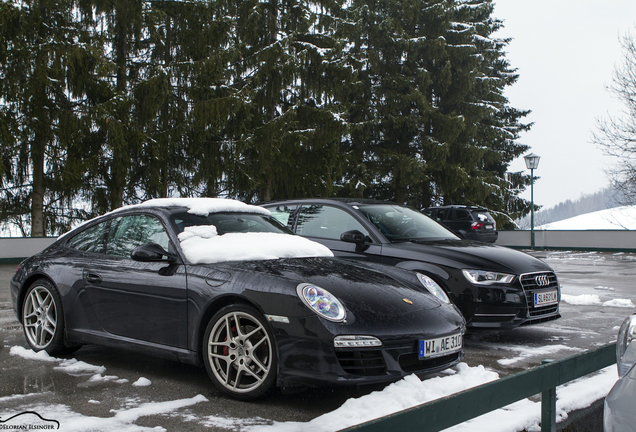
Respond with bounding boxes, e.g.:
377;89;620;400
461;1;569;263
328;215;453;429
203;304;277;400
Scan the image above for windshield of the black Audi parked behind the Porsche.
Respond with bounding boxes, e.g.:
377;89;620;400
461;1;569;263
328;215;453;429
358;204;459;241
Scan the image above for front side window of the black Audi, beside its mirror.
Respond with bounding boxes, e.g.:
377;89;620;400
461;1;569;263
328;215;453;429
296;205;369;240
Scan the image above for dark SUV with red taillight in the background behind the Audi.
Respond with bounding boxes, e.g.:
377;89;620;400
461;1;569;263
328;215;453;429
422;205;499;243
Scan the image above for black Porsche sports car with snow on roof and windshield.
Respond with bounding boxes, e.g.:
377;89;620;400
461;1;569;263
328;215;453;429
11;198;465;399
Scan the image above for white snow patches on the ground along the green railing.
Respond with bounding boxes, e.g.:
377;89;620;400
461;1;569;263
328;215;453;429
0;346;617;432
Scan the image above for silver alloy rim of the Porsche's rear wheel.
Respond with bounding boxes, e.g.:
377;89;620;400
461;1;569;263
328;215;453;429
22;286;58;350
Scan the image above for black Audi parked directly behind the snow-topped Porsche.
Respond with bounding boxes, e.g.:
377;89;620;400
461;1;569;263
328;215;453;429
263;199;561;328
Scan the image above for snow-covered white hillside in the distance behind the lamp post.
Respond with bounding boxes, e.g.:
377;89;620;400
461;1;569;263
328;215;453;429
515;187;621;229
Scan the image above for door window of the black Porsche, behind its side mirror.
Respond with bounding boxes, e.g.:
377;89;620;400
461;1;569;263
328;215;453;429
106;215;170;257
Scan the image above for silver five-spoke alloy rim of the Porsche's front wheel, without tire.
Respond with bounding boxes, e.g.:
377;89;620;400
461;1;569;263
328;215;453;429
207;311;273;394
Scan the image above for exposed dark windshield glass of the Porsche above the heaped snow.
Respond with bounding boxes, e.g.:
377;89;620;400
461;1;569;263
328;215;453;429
171;212;293;235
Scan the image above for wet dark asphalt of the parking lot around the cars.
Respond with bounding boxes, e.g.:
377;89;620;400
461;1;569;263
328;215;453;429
0;252;636;431
